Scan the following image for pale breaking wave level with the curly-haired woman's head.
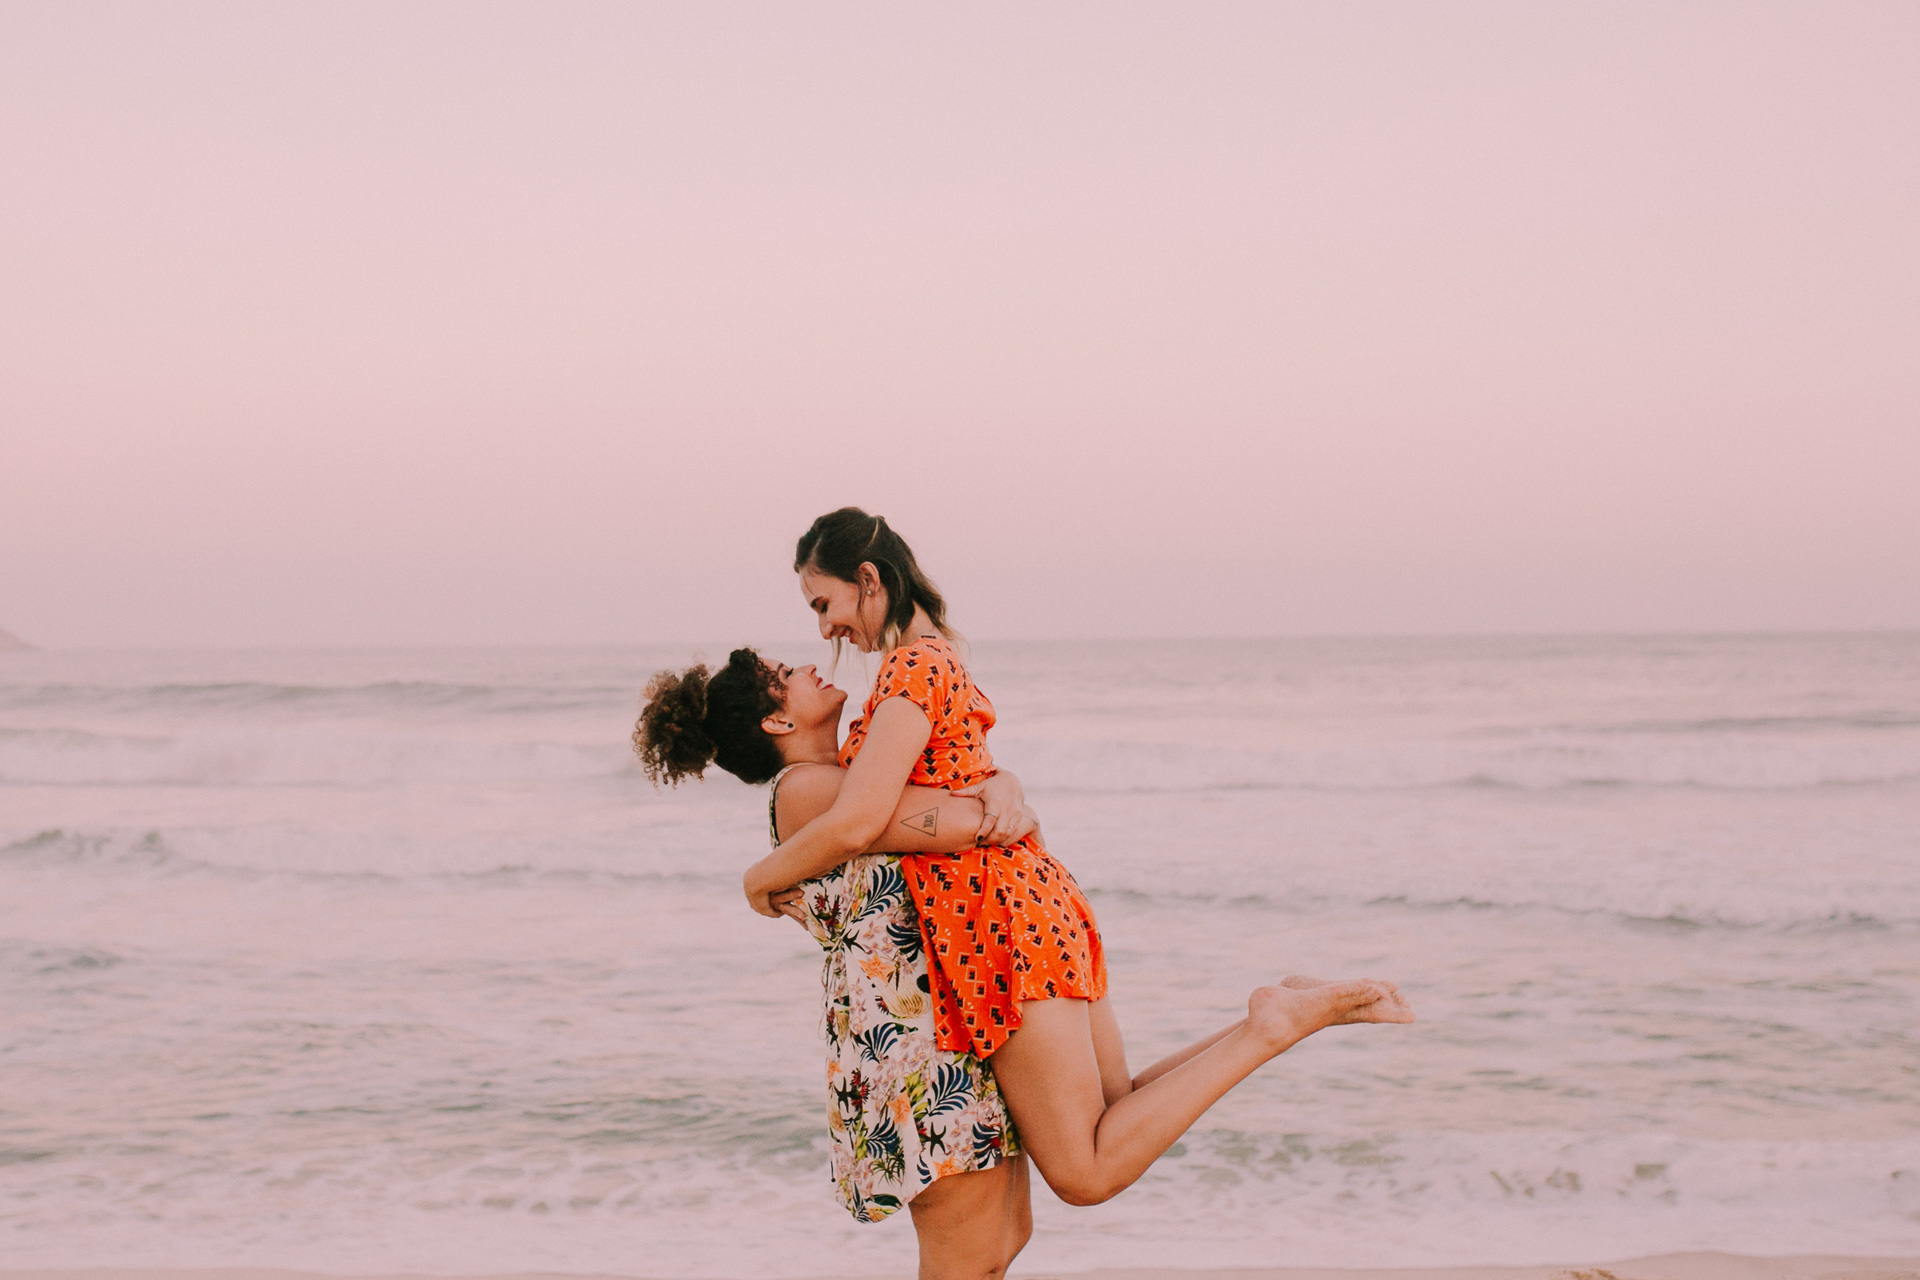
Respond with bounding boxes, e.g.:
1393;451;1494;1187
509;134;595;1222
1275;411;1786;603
0;723;1920;794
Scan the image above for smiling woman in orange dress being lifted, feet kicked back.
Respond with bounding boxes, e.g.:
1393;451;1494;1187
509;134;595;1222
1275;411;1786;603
745;507;1413;1205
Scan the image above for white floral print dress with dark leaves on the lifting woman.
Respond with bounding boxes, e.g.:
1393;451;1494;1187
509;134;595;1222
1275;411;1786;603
768;766;1020;1222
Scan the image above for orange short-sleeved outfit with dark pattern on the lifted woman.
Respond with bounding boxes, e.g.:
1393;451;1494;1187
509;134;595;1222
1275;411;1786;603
839;639;1106;1057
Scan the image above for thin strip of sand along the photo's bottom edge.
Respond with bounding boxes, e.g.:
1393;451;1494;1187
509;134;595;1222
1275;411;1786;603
0;1253;1920;1280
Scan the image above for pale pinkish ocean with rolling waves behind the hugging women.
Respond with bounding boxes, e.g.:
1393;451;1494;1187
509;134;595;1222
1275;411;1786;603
0;633;1920;1278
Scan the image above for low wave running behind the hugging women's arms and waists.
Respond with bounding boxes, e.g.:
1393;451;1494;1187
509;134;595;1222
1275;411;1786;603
11;827;1920;936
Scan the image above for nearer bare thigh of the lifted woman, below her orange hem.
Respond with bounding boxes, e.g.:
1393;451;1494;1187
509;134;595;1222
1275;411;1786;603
991;1000;1106;1190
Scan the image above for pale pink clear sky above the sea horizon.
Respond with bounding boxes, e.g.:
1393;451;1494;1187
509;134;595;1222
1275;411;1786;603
0;0;1920;645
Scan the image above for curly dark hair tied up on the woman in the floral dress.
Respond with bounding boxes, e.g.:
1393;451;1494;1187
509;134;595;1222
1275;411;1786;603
634;649;787;787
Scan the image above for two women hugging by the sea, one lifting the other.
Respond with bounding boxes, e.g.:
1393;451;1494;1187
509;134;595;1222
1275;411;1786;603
634;507;1413;1280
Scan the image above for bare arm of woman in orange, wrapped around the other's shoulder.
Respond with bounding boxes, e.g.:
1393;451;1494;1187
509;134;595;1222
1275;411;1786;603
741;699;933;915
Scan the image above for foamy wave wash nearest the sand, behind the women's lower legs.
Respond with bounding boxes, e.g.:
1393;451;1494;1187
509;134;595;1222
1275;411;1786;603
4;1113;1920;1278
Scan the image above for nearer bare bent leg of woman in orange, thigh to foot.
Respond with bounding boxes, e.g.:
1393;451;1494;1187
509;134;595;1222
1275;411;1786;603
993;981;1413;1205
